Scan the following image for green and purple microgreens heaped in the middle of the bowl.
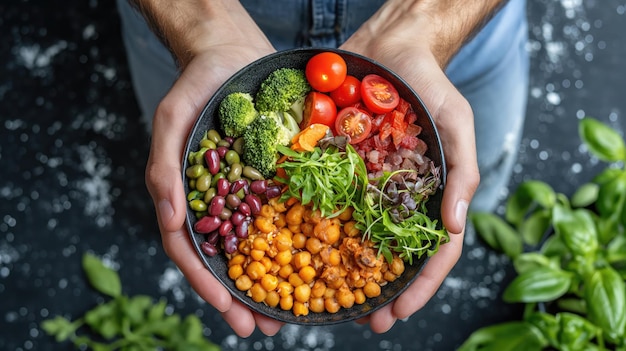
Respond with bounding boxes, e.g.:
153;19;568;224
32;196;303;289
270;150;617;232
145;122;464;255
277;137;448;264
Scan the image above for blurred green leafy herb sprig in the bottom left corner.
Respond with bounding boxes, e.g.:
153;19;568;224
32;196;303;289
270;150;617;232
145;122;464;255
41;253;220;351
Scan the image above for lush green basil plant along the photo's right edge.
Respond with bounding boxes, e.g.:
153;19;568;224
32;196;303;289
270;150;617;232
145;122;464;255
458;118;626;351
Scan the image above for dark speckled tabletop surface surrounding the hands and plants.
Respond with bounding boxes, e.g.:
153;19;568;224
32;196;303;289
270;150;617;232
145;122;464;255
0;0;626;350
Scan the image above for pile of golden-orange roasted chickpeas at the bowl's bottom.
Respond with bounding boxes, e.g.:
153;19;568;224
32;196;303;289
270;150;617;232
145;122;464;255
227;199;404;316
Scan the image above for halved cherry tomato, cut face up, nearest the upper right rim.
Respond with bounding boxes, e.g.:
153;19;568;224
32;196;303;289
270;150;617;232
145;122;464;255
361;74;400;113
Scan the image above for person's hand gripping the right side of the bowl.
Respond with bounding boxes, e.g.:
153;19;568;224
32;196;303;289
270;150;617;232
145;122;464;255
341;1;490;333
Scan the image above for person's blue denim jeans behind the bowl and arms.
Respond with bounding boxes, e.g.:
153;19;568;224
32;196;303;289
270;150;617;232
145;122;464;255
117;0;529;211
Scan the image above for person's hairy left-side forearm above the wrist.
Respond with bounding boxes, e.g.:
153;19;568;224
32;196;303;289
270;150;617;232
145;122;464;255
129;0;255;67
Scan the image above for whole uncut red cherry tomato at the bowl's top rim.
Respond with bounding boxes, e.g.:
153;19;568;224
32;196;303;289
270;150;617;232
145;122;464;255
305;52;348;93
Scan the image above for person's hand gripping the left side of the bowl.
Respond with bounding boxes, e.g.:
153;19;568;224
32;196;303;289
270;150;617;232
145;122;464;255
141;2;281;337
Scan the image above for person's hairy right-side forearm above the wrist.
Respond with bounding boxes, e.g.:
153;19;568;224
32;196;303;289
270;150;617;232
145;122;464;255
354;0;507;67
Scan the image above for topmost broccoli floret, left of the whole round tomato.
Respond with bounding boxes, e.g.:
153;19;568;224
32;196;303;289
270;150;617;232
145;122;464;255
255;68;311;114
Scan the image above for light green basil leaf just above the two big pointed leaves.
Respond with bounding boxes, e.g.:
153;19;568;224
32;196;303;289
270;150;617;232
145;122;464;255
552;205;598;258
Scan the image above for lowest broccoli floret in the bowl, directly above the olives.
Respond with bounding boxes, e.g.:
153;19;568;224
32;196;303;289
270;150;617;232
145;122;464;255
243;115;280;179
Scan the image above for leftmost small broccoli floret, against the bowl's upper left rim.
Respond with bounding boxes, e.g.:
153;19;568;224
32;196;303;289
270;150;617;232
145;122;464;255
218;92;259;138
